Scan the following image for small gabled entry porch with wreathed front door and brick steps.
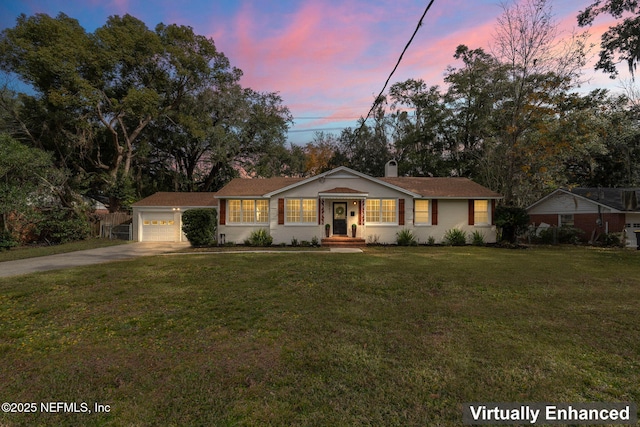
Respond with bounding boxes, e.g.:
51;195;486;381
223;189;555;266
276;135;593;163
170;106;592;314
318;187;368;247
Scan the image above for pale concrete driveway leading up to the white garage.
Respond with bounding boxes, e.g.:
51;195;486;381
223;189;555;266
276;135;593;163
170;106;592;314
0;242;189;277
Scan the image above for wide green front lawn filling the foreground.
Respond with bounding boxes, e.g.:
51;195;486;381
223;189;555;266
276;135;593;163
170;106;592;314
0;247;640;426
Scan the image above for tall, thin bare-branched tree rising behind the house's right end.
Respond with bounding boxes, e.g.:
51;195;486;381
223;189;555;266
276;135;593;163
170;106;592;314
485;0;585;205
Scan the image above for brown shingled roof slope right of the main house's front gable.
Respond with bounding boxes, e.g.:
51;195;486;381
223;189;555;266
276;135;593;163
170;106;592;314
378;177;502;199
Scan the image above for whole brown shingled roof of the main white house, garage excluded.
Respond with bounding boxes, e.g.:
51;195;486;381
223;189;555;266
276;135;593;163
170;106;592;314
216;166;502;199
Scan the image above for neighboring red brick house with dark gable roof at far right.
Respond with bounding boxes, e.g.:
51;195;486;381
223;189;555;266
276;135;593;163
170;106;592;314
527;188;640;247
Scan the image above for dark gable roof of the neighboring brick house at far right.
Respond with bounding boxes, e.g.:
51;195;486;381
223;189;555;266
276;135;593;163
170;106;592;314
527;187;640;212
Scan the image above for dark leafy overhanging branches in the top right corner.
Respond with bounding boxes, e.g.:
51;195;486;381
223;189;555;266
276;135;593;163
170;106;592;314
578;0;640;79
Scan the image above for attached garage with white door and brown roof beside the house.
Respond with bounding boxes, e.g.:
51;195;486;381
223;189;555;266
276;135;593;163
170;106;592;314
132;192;218;242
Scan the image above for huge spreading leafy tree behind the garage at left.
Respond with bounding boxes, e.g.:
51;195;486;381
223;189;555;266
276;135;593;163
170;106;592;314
0;14;291;209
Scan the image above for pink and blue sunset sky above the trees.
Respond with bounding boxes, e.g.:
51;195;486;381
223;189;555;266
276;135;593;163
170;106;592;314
0;0;619;144
